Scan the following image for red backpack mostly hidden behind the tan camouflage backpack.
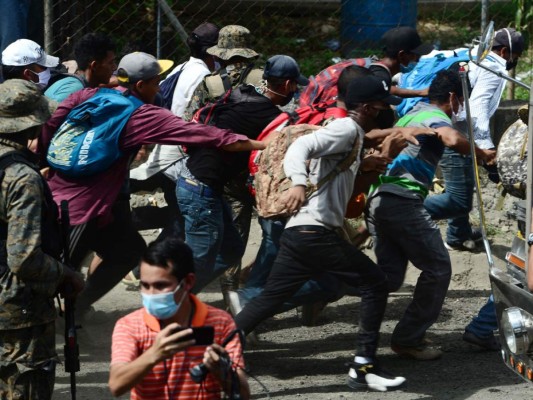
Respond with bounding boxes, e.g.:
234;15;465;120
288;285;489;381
248;104;347;196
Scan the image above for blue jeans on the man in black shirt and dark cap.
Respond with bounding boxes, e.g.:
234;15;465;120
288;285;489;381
176;178;244;293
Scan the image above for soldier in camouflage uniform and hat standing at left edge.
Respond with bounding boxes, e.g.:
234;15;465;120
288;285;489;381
0;79;83;400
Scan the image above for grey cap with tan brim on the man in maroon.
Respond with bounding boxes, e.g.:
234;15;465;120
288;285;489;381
117;51;174;83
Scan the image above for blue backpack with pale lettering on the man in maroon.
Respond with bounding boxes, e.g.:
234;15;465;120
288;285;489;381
46;88;144;178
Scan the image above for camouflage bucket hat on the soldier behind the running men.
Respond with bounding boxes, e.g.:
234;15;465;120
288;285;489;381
207;25;259;60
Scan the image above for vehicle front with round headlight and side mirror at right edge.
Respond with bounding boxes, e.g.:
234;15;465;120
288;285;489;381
468;22;533;382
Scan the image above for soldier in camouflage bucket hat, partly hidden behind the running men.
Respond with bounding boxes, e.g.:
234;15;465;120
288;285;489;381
183;25;263;300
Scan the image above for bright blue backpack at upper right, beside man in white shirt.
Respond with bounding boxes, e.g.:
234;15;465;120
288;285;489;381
396;49;470;117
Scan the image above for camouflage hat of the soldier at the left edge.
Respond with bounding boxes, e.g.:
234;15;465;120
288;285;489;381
0;79;57;134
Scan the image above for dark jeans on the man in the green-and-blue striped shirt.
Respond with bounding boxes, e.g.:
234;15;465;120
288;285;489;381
367;193;452;346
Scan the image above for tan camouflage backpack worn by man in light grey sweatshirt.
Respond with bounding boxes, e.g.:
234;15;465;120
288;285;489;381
254;124;359;218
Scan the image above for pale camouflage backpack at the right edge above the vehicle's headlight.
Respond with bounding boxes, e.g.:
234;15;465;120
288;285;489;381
496;106;528;199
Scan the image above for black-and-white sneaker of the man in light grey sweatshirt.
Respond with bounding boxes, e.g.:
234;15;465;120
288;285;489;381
346;362;405;392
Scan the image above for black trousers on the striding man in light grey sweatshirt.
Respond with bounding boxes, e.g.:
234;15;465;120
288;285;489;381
235;226;388;357
